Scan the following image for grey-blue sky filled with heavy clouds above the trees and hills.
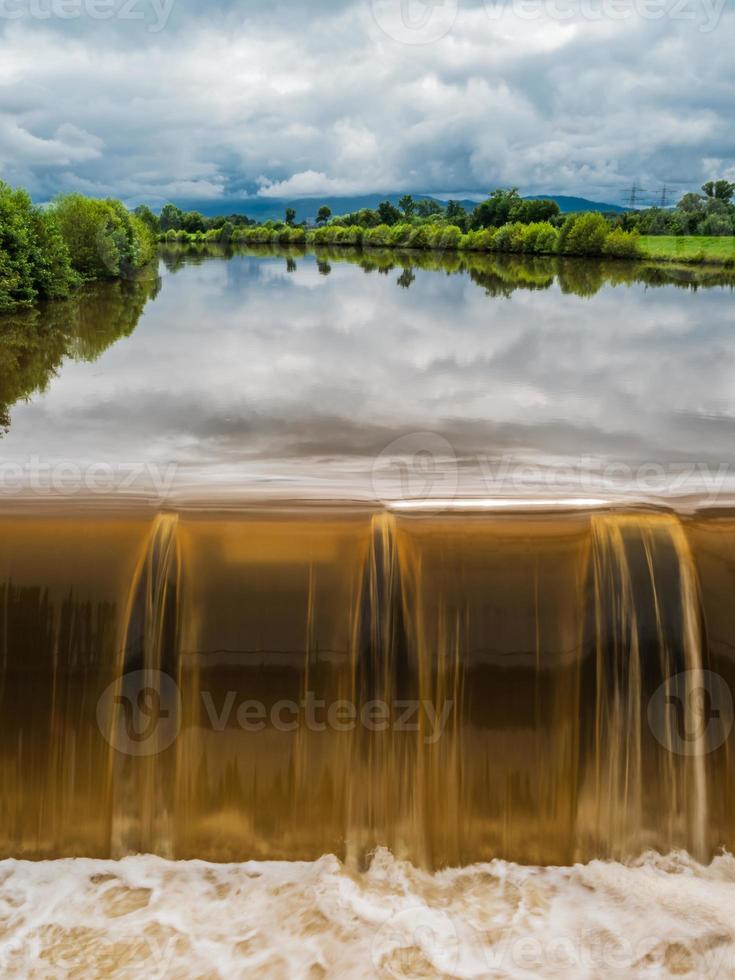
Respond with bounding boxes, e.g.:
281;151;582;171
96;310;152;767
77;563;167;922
0;0;735;210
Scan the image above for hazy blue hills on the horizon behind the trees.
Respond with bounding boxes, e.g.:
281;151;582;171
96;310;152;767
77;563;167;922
171;193;626;221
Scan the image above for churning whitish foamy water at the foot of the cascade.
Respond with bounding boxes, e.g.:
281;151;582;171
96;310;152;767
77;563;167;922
0;851;735;978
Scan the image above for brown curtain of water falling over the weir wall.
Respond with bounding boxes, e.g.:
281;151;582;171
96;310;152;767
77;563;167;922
0;506;735;867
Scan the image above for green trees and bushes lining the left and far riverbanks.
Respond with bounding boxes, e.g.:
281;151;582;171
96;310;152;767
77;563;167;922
0;180;735;312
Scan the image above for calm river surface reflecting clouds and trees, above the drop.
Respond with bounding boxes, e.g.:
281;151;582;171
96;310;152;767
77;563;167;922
0;245;735;501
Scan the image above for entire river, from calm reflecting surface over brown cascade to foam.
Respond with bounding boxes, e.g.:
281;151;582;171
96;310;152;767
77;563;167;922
0;249;735;980
